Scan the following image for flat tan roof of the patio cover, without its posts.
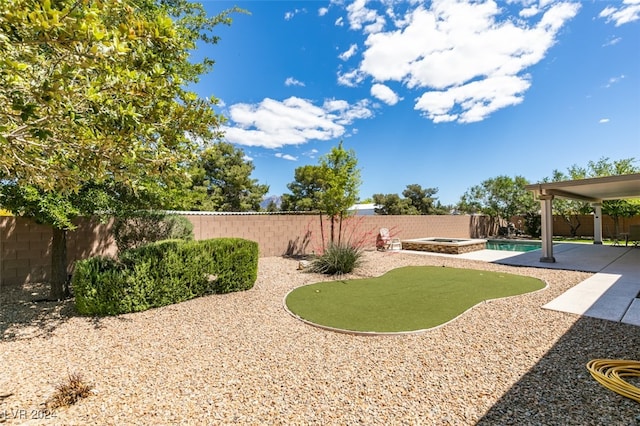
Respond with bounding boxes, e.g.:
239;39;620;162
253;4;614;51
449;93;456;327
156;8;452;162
525;173;640;202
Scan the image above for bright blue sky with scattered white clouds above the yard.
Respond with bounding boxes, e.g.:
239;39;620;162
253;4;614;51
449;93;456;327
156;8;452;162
195;0;640;204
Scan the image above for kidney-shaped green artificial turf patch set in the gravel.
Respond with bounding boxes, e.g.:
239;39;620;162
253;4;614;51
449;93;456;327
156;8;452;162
285;266;545;332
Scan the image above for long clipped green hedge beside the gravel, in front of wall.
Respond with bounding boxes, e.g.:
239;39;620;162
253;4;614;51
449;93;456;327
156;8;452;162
72;238;258;315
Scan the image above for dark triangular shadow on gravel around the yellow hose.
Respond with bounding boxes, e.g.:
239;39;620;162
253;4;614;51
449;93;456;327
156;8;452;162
477;317;640;425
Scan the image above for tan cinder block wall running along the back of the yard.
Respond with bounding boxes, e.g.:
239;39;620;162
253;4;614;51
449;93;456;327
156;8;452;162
0;214;479;286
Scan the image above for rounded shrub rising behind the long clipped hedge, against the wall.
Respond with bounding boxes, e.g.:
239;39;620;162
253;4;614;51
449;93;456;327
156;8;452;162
113;212;193;252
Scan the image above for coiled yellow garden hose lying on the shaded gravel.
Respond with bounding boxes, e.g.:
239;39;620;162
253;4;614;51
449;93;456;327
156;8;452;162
587;359;640;402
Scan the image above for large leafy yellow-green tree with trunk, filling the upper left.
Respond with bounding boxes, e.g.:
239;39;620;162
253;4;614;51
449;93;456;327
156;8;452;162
0;0;239;299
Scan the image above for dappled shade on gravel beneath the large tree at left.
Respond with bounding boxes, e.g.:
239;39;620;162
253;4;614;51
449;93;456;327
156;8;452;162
0;283;128;342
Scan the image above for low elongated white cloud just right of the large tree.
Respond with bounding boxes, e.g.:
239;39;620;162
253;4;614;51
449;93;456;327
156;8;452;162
221;97;373;148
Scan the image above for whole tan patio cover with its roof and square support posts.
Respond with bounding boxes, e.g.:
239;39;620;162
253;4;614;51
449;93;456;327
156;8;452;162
525;173;640;262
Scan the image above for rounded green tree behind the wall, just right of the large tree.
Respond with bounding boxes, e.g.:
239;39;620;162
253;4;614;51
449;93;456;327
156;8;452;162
185;142;269;212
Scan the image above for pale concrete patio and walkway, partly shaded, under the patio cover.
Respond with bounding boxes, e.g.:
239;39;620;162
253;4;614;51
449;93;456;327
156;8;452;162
402;243;640;326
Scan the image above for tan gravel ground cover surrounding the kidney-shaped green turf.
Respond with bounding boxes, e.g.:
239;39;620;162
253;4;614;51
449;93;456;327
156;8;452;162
0;252;640;425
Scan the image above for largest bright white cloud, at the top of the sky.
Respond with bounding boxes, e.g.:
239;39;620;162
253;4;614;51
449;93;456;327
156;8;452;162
350;0;580;122
